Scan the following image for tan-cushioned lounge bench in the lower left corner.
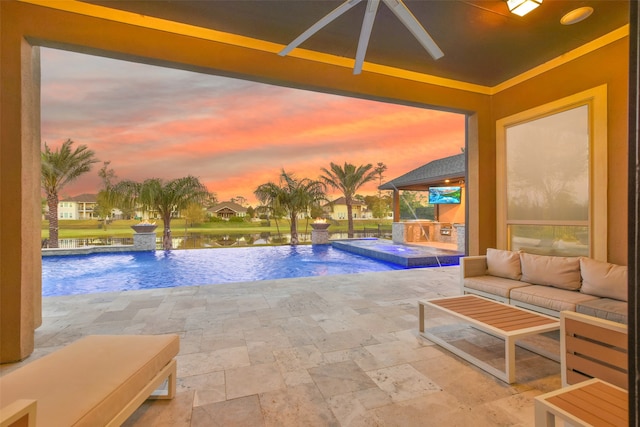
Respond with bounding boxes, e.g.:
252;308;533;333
0;334;179;427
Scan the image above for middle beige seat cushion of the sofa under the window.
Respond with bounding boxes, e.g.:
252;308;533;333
510;285;598;312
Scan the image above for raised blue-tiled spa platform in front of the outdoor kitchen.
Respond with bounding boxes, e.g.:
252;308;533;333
331;238;464;268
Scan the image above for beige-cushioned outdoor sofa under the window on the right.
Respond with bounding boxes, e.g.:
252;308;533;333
460;248;628;324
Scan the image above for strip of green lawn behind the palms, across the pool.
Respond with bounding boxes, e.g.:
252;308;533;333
41;218;392;239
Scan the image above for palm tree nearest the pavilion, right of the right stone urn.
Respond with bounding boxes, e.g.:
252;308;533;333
321;162;377;237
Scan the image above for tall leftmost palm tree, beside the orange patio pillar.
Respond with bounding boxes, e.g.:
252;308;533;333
40;139;98;248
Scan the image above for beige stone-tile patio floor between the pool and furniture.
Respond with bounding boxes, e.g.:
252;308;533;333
0;266;560;427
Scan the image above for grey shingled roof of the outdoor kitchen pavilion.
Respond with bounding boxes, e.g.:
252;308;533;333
378;153;466;190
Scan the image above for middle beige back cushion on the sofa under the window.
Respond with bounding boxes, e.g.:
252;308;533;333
520;252;581;291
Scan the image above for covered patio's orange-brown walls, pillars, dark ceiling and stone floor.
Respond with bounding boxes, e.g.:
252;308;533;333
0;0;640;425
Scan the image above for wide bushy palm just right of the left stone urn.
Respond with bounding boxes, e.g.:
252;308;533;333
111;176;209;250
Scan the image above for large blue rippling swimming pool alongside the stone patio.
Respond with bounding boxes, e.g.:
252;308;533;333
42;245;404;296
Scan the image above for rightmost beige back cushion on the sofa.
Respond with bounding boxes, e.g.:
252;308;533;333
580;258;629;301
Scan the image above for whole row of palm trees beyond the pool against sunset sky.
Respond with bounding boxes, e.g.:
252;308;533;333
41;139;388;250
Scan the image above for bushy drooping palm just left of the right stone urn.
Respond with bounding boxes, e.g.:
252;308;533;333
253;169;325;246
